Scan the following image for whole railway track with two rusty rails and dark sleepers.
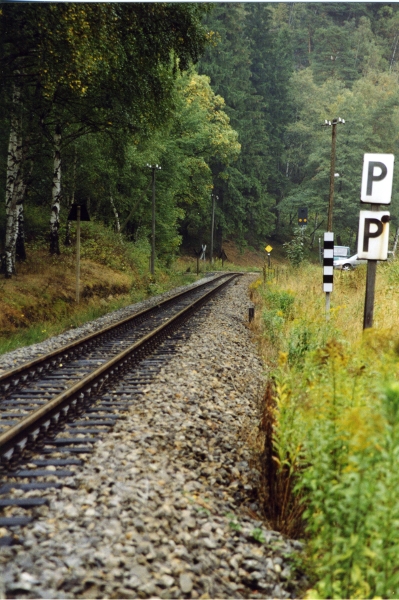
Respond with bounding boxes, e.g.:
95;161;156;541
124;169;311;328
0;274;241;545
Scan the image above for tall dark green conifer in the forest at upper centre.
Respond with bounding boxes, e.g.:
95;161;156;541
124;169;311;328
200;4;292;243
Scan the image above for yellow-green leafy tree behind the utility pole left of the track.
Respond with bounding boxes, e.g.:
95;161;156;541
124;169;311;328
55;69;240;262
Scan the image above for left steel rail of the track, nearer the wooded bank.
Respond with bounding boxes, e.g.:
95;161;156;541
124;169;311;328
0;273;231;392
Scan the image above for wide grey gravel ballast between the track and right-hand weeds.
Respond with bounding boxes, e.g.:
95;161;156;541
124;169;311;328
0;275;304;598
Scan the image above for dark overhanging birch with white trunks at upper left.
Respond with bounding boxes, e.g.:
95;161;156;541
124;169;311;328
0;3;211;276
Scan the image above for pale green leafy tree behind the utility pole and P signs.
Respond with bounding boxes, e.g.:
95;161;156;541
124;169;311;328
281;68;399;246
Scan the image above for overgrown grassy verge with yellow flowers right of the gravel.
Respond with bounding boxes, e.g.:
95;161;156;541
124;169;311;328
253;262;399;598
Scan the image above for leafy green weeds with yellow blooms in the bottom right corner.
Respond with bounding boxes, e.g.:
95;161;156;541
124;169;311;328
298;383;399;598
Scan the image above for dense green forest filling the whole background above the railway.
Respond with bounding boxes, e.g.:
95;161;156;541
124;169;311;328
0;2;399;276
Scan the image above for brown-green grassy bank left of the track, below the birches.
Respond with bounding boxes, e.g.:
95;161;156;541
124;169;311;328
0;222;260;354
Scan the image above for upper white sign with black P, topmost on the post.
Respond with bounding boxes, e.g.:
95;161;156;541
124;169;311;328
360;154;395;204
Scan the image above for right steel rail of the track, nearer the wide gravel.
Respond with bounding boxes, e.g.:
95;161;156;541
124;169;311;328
0;273;239;462
